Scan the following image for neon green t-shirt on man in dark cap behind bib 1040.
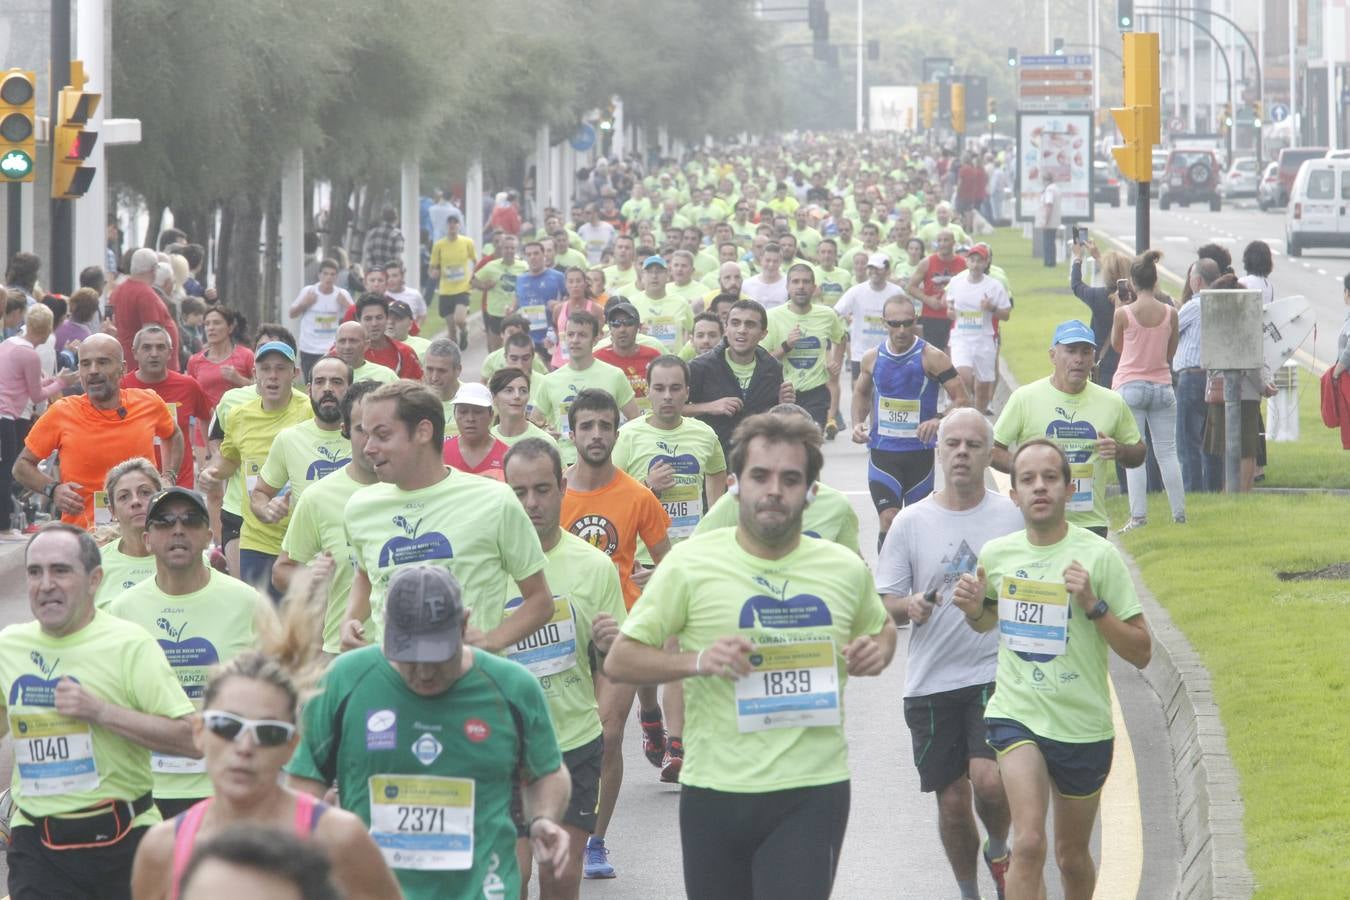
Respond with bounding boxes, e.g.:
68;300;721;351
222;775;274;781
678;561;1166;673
108;567;265;800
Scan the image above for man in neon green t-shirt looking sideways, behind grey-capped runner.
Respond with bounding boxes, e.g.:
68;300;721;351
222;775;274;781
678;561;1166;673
342;382;554;652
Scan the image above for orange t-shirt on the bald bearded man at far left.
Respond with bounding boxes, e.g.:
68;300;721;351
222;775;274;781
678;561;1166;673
23;387;177;528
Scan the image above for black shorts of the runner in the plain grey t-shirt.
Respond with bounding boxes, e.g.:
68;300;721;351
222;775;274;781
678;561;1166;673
905;681;994;793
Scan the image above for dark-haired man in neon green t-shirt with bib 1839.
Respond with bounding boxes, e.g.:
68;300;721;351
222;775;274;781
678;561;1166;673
605;413;895;897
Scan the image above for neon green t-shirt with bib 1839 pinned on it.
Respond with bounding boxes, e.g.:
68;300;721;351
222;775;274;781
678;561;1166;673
622;529;891;793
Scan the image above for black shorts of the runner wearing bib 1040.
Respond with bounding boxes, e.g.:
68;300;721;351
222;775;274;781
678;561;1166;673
8;824;150;900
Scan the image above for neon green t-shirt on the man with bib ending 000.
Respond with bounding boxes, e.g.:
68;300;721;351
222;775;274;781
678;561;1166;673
504;530;628;753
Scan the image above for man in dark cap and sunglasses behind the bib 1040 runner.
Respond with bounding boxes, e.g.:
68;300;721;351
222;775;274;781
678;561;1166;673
108;486;263;819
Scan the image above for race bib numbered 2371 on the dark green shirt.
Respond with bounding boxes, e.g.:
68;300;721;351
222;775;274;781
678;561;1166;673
370;775;474;870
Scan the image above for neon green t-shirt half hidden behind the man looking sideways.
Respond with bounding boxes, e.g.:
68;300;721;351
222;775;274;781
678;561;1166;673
281;466;366;656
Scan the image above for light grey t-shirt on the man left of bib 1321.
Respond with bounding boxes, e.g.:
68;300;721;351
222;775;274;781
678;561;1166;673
876;491;1025;698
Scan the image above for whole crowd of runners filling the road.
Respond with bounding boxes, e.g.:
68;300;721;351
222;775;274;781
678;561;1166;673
0;136;1156;900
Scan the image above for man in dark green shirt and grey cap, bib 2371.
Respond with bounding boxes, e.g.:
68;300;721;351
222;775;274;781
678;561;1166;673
286;569;570;900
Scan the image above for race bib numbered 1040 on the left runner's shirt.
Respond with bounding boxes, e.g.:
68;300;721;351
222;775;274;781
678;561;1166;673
9;712;99;797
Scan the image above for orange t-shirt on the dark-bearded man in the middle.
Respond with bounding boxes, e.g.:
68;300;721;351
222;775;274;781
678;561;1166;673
562;471;671;609
